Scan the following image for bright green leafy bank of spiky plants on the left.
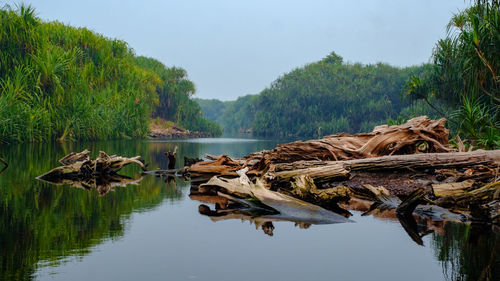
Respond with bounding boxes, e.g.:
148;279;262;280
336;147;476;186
0;5;218;142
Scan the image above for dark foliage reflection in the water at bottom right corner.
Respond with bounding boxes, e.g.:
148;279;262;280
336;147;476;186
432;223;500;281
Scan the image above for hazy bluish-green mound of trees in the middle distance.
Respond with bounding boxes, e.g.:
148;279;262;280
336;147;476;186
200;53;424;137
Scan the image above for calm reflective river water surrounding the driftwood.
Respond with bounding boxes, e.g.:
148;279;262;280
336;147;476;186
0;139;500;281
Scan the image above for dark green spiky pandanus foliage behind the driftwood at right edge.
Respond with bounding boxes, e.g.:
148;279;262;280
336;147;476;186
406;0;500;148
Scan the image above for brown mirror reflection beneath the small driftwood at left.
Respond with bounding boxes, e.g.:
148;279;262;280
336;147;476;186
41;174;143;196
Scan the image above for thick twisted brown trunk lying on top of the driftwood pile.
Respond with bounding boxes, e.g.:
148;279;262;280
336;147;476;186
254;116;451;169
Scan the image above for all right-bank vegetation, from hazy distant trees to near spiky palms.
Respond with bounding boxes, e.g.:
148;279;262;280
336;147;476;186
197;0;500;148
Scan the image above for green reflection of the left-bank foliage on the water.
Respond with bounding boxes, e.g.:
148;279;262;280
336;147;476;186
0;142;185;280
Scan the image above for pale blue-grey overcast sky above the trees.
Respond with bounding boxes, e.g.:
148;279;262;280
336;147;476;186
0;0;469;100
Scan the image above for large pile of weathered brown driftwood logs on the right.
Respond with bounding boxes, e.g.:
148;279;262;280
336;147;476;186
187;116;500;230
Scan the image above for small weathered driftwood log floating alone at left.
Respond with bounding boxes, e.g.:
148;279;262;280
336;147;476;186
39;151;146;181
